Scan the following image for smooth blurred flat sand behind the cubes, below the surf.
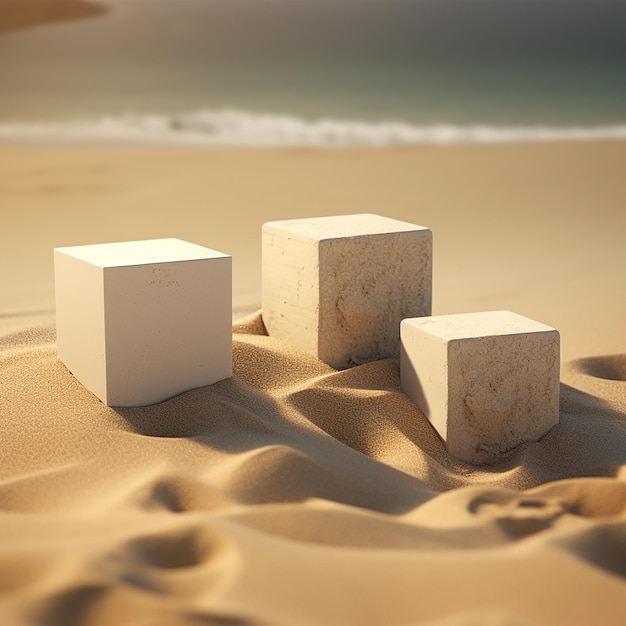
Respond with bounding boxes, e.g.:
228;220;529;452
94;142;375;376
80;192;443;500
0;141;626;361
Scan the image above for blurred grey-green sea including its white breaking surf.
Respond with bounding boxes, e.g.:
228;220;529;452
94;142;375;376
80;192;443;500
0;0;626;145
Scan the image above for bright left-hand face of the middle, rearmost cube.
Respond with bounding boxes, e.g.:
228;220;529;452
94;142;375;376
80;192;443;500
261;226;319;356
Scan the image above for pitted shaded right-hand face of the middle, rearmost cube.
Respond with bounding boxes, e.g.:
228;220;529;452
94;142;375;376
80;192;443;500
318;228;432;369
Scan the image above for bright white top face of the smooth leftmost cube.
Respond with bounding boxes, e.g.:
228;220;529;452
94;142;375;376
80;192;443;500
55;238;229;268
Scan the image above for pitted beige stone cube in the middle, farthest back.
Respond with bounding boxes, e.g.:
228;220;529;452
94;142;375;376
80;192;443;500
262;214;432;369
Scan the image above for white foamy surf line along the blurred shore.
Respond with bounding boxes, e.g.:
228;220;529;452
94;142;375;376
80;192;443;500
0;110;626;147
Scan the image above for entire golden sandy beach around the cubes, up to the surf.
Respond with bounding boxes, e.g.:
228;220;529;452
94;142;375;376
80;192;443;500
0;141;626;626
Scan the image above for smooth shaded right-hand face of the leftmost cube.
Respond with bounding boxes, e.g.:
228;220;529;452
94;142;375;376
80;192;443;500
104;257;232;406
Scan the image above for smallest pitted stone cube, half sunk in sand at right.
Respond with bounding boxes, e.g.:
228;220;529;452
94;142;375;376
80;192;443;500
400;311;560;464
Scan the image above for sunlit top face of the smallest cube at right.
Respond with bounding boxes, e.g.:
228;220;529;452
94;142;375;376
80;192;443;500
402;311;557;341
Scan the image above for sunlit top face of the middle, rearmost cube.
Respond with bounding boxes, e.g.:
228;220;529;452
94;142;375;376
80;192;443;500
263;213;429;242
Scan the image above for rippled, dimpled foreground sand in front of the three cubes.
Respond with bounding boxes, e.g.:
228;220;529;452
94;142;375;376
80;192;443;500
0;315;626;626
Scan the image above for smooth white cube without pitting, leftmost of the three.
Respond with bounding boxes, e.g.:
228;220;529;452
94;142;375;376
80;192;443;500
54;239;232;406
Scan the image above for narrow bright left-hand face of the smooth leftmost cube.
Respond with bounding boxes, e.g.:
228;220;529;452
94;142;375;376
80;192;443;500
54;250;107;402
